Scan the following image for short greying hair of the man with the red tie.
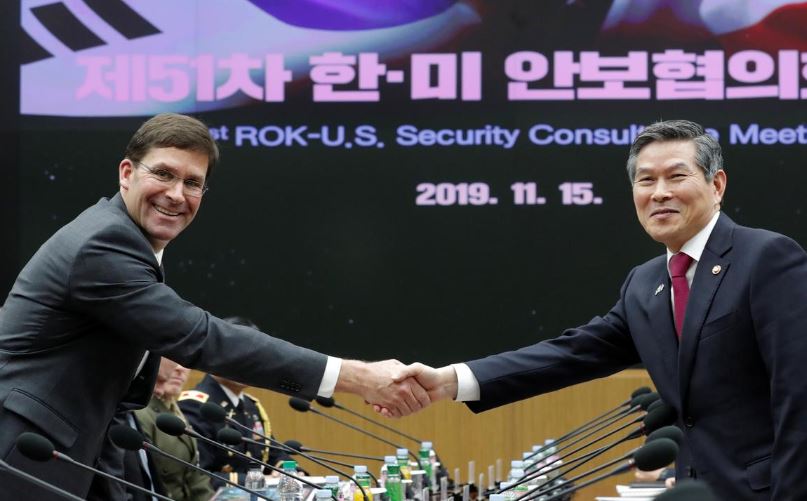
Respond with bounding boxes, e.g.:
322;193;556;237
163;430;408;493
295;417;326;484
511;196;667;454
627;120;723;183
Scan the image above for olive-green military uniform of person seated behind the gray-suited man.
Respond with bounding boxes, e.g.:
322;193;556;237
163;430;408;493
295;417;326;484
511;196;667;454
134;396;218;501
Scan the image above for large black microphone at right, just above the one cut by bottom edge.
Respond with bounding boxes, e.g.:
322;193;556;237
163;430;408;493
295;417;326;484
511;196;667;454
516;438;678;501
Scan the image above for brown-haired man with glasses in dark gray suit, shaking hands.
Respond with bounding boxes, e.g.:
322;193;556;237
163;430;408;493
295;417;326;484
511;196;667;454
0;114;429;500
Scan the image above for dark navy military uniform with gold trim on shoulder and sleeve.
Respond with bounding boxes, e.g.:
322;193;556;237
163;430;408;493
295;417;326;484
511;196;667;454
179;374;292;487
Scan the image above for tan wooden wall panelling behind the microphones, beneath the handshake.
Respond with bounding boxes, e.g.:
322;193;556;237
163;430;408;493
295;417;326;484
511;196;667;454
188;370;651;501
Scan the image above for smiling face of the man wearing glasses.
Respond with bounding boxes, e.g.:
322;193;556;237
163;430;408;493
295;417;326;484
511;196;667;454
118;148;208;252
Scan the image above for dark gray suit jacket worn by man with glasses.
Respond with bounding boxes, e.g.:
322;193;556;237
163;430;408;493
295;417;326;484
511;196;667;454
0;194;327;500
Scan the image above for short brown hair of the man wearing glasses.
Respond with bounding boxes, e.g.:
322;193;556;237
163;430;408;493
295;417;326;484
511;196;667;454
124;113;219;182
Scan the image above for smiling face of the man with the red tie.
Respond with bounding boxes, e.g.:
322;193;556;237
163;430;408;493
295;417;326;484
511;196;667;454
633;140;726;252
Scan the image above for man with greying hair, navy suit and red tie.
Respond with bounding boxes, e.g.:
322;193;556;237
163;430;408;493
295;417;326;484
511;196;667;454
408;120;807;501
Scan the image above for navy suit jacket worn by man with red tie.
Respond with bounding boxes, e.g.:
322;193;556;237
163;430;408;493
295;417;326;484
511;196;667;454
468;214;807;501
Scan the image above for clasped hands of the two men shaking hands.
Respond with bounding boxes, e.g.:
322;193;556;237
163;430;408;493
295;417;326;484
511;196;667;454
336;360;457;417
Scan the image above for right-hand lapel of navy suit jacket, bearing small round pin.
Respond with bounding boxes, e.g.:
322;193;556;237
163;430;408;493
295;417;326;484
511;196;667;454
678;214;734;404
